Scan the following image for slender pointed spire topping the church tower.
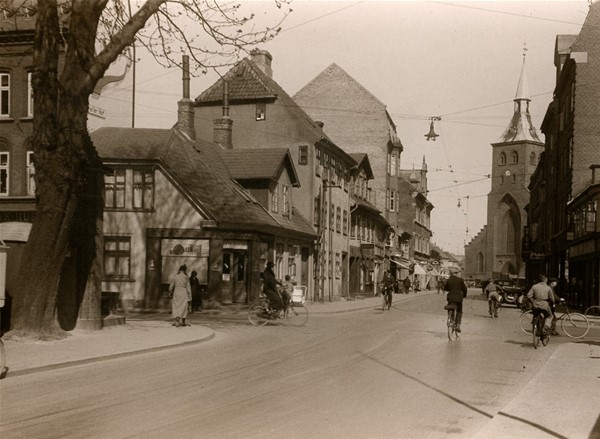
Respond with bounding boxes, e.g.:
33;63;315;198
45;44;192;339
502;46;541;142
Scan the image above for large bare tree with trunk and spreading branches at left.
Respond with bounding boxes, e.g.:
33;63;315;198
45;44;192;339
0;0;291;339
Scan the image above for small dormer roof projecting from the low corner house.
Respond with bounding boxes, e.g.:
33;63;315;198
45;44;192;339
221;148;300;187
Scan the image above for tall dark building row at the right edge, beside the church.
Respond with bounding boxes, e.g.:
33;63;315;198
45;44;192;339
527;2;600;308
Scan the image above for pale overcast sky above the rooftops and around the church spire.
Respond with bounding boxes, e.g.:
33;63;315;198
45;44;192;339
90;0;588;254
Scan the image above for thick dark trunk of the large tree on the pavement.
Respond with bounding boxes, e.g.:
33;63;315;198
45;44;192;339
11;0;103;339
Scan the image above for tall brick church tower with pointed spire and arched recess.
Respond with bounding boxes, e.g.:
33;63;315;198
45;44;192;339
482;51;544;279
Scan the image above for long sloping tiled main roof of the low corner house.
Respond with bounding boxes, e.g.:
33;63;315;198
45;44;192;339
91;127;316;237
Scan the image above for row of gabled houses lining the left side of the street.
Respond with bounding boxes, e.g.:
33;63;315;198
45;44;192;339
0;12;443;326
